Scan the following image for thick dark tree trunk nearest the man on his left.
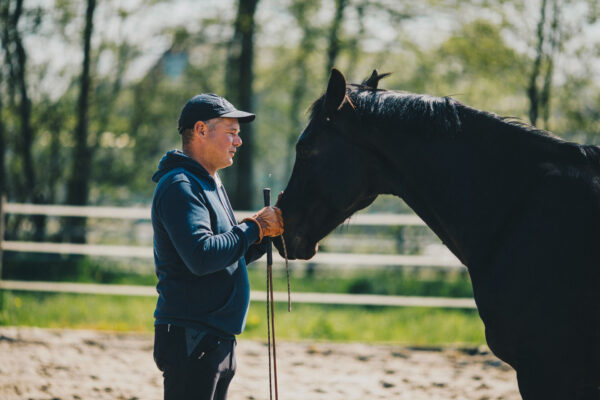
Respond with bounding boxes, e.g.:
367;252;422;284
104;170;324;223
66;0;96;243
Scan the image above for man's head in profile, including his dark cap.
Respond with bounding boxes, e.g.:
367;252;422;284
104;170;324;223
179;94;255;176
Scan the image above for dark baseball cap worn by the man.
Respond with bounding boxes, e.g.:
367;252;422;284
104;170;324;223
179;93;256;133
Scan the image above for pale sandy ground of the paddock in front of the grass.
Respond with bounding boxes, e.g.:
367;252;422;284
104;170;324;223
0;327;520;400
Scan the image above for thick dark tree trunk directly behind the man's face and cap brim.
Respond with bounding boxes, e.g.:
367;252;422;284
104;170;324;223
223;0;259;210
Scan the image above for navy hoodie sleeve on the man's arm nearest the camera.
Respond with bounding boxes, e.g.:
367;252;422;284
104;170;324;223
156;180;259;276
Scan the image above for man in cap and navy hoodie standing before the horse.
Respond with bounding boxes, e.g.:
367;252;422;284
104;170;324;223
152;94;283;400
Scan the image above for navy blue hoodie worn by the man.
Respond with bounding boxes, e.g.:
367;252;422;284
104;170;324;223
152;150;265;337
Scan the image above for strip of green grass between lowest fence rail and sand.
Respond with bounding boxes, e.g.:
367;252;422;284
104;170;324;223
0;291;485;346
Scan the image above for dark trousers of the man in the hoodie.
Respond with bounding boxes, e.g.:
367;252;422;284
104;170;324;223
154;325;236;400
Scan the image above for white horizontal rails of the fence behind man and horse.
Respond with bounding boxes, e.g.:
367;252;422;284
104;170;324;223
0;203;475;308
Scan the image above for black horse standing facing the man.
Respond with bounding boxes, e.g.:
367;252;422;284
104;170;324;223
275;69;600;400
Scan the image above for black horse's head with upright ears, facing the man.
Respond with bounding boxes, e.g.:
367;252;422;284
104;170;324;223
275;69;384;259
